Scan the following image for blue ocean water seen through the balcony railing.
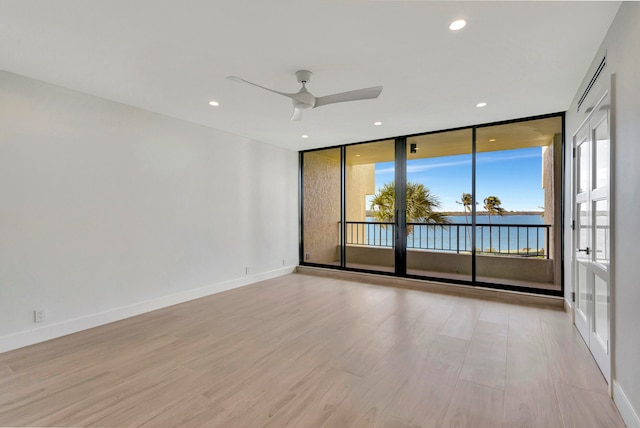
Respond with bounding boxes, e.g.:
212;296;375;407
362;214;548;255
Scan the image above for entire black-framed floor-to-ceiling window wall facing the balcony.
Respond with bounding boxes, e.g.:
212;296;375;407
300;115;563;294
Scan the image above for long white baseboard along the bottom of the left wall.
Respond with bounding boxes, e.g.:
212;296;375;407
0;266;296;353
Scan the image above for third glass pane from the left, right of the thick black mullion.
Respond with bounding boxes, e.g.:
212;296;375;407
407;129;473;281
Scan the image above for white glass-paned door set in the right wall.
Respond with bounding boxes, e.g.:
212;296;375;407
573;95;611;382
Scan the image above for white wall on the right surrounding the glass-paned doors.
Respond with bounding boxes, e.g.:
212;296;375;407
565;2;640;427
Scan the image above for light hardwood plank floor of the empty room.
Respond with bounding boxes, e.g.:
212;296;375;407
0;273;624;428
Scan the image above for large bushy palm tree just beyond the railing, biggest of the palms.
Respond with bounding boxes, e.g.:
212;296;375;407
371;181;451;235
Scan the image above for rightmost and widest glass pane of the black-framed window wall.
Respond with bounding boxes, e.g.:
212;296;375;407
475;117;562;290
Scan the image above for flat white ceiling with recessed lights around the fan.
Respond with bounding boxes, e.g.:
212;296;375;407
0;0;620;150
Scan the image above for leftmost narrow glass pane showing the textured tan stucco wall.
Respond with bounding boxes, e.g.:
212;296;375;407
302;148;340;265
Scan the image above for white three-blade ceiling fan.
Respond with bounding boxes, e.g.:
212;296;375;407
227;70;382;121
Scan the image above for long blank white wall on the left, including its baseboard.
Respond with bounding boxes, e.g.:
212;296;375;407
0;72;298;352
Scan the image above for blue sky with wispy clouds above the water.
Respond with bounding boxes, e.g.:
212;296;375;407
367;147;544;211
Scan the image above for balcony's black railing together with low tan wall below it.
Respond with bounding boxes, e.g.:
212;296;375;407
339;221;557;289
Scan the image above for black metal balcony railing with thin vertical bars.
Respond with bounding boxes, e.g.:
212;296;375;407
346;221;551;259
